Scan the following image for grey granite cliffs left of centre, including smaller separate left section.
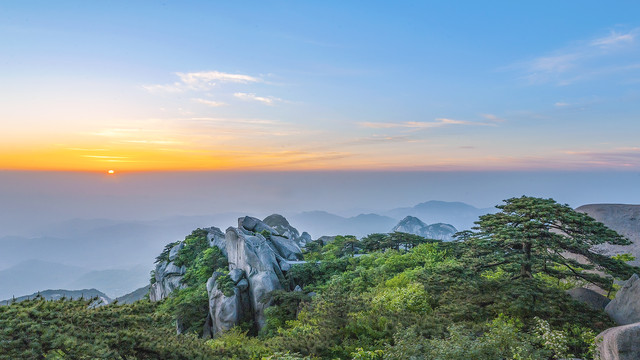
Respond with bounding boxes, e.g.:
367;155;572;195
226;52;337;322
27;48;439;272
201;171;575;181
150;215;310;336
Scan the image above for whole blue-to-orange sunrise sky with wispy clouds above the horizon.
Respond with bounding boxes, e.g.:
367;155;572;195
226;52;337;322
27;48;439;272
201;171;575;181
0;0;640;171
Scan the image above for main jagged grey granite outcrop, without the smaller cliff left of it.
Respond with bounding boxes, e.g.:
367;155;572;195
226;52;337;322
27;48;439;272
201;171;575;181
207;215;302;335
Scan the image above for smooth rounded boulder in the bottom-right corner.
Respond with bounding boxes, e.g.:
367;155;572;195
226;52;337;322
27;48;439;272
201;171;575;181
596;323;640;360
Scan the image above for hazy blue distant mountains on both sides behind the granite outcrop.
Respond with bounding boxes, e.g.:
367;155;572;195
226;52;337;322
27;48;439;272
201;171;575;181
0;201;490;299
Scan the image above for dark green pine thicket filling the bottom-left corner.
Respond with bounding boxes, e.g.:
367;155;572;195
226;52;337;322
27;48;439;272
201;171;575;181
0;298;214;360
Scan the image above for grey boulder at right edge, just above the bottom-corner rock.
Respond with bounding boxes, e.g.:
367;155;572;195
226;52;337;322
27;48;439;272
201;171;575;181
604;274;640;325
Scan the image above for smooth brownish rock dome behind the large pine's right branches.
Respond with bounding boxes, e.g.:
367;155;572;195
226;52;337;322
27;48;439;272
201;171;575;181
576;204;640;266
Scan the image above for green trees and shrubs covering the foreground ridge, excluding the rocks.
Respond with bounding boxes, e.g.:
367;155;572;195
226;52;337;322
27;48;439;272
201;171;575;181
0;197;637;360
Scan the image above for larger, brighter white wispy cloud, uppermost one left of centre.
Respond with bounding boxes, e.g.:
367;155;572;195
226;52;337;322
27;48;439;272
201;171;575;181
142;71;262;92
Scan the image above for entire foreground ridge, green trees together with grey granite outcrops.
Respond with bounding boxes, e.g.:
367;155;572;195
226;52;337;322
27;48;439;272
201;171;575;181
0;197;640;360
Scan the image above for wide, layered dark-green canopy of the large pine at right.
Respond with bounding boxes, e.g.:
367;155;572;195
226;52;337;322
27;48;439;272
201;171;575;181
460;196;634;288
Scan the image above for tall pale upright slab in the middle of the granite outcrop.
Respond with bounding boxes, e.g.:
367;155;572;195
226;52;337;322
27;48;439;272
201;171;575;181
226;228;284;329
